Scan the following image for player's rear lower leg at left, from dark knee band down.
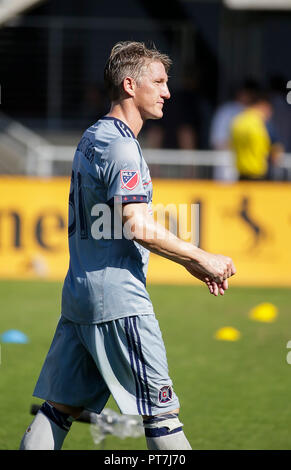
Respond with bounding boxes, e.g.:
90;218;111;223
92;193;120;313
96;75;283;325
19;401;83;450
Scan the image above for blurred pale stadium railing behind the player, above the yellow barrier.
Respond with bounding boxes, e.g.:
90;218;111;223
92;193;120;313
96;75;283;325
0;113;291;181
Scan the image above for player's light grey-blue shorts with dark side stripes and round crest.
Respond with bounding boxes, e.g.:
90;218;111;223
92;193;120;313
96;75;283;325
33;315;179;415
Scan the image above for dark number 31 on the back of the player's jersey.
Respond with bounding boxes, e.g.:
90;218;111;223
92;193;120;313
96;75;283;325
68;170;88;240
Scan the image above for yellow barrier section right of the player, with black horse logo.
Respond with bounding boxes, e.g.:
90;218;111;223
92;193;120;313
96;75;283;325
149;180;291;286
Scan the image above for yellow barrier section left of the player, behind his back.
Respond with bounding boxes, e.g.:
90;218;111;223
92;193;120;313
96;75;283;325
0;177;69;280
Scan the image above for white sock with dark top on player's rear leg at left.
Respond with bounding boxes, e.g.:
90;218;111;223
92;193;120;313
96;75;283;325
19;403;73;450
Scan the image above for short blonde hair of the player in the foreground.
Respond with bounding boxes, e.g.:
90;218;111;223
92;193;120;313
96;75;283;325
104;41;172;101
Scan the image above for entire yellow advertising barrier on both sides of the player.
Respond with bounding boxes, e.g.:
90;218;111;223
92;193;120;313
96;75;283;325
0;177;291;286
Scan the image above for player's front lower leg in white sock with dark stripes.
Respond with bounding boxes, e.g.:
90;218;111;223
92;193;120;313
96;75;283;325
143;408;191;450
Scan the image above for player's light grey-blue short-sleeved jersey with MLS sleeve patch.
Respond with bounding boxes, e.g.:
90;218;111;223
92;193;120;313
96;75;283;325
62;117;153;323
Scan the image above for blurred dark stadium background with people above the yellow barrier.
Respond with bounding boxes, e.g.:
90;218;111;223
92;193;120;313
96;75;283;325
0;0;291;181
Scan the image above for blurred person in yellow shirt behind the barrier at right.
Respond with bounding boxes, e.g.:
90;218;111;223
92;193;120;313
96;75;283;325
230;93;283;181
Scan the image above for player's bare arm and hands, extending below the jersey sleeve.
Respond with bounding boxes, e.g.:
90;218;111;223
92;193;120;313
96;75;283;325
122;203;236;295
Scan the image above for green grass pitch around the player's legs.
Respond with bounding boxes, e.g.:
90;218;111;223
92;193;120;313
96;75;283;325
0;281;291;450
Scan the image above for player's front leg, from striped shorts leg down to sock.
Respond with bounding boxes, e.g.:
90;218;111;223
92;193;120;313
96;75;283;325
80;315;191;450
